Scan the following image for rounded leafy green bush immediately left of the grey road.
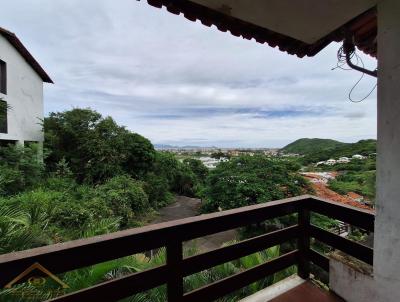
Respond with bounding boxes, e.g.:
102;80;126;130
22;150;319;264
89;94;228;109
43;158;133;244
95;175;150;226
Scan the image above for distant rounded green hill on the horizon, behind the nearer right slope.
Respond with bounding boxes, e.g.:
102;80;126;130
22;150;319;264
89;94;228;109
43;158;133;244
281;138;347;155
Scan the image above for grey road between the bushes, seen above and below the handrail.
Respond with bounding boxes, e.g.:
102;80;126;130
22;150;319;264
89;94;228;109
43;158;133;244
152;196;237;252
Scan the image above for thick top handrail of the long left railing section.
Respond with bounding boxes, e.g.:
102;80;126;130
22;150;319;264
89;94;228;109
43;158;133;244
0;195;304;287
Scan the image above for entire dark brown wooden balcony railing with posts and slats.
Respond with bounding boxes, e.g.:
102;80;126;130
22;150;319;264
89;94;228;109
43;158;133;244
0;195;374;302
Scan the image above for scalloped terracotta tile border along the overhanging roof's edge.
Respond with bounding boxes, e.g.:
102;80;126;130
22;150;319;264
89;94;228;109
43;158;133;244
147;0;377;58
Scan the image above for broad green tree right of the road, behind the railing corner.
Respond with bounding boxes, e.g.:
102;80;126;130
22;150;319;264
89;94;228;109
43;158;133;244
203;156;309;212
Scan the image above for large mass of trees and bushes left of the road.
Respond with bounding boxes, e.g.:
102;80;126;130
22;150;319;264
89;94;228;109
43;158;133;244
0;109;207;253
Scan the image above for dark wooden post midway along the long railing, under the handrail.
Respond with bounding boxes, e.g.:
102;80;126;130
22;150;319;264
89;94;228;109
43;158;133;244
167;240;183;302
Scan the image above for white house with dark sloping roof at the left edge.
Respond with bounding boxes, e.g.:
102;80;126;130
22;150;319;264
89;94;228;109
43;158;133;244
0;27;53;145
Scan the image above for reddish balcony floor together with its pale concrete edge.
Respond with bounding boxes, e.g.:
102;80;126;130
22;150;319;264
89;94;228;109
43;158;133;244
240;276;344;302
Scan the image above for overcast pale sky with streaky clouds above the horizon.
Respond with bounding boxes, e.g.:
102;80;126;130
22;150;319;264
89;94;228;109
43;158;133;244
0;0;376;147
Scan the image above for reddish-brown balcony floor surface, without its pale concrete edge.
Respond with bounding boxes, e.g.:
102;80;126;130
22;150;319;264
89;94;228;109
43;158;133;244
268;282;344;302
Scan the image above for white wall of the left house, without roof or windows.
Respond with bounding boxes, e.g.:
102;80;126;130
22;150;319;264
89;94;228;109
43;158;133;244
0;35;43;142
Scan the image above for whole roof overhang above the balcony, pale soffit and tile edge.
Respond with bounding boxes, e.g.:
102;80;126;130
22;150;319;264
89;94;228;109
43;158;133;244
147;0;377;57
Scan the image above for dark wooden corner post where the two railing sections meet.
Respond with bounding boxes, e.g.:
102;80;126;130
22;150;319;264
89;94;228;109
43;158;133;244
297;208;310;279
